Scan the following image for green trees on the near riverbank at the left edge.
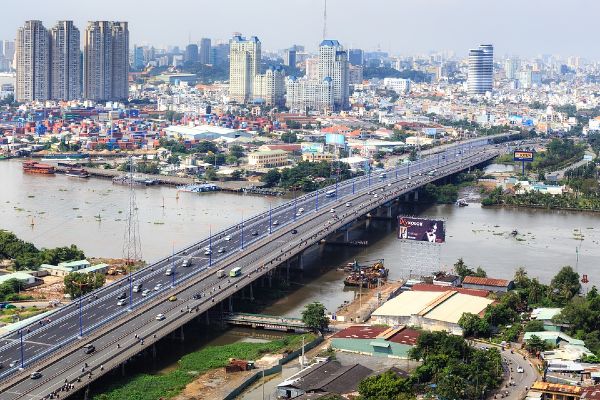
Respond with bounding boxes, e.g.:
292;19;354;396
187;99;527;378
0;230;85;270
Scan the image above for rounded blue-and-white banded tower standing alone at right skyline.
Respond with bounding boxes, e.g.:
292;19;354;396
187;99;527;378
467;44;494;95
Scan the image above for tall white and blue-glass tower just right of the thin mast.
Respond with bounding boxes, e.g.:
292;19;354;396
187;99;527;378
319;40;350;110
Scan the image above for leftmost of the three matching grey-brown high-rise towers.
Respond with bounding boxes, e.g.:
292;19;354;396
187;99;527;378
15;21;50;102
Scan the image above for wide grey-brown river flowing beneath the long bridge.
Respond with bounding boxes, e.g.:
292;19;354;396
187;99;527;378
0;160;600;304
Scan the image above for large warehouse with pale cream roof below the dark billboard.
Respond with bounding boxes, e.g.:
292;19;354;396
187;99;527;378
372;290;493;335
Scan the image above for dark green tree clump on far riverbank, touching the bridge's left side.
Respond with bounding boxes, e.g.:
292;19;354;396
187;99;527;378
261;161;352;192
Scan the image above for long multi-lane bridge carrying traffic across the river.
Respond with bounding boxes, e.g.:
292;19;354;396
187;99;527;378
0;139;500;400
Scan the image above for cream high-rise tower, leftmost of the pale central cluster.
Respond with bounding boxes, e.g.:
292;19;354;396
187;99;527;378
229;34;261;103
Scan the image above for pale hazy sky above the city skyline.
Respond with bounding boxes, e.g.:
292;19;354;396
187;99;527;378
0;0;600;59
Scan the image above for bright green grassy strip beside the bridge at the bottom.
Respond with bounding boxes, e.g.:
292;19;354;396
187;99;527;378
93;334;315;400
